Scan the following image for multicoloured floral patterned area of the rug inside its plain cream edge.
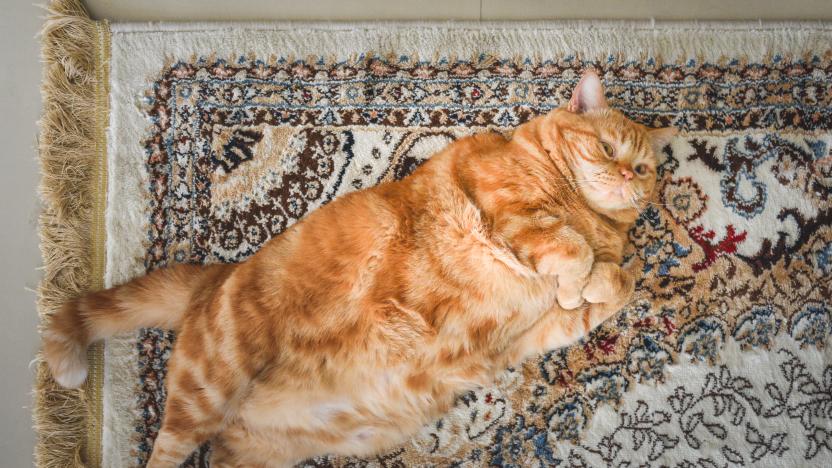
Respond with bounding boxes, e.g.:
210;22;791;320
134;56;832;467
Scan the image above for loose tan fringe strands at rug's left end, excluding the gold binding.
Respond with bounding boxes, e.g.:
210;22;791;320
34;0;98;468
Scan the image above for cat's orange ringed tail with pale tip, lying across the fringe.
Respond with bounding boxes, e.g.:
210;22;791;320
42;265;232;388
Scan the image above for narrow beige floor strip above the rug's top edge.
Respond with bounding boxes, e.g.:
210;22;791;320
87;0;832;21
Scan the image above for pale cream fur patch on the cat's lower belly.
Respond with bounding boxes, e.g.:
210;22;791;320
235;362;489;456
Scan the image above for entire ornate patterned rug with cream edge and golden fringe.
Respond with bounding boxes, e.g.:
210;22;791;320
36;0;832;467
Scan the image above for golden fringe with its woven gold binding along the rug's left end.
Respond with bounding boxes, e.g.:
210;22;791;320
33;0;110;468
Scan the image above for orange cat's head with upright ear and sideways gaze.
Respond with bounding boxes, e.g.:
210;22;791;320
553;71;676;221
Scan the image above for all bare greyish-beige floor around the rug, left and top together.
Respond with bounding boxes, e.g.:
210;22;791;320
0;0;832;468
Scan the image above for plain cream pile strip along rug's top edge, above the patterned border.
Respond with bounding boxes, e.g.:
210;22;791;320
112;20;832;63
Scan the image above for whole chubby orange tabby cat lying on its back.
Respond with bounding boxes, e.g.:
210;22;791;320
43;72;672;467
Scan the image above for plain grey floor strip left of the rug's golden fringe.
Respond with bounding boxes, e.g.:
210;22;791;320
0;0;41;468
